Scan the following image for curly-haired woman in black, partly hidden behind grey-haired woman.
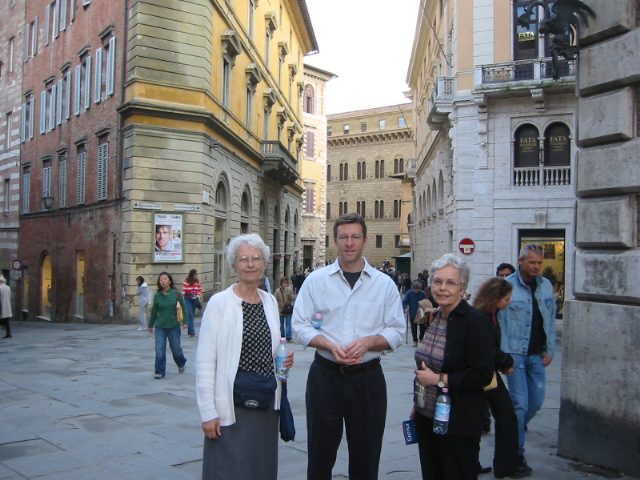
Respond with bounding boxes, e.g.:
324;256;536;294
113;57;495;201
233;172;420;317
473;277;531;478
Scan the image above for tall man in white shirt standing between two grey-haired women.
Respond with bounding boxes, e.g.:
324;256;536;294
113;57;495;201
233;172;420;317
293;213;405;480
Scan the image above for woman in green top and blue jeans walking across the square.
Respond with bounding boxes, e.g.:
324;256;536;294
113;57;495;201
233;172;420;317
149;272;187;380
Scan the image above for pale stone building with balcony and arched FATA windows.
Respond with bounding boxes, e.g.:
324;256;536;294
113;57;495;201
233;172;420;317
407;0;577;300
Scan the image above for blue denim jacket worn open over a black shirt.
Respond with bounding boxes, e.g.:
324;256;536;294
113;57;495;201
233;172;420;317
498;269;556;357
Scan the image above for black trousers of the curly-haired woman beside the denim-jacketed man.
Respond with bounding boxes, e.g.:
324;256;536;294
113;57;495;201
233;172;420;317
486;374;519;477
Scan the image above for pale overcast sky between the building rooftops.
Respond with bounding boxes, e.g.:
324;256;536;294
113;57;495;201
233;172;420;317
304;0;419;114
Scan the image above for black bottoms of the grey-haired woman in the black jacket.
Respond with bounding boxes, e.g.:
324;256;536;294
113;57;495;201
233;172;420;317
414;413;480;480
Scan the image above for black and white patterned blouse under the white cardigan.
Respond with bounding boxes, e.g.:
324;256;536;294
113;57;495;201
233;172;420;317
238;301;273;377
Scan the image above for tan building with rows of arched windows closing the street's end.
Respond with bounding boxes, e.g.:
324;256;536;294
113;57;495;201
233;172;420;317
325;103;415;273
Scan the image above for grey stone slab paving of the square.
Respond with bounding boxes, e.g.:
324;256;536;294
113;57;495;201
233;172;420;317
0;319;630;480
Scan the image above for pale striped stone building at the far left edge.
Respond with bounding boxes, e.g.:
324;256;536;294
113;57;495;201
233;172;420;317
0;0;26;310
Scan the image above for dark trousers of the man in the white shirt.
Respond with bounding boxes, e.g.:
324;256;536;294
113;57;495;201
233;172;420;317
306;361;387;480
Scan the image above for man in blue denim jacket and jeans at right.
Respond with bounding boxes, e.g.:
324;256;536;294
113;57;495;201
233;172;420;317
498;243;556;472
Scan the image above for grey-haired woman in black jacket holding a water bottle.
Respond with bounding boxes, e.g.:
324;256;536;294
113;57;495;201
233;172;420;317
411;254;494;480
